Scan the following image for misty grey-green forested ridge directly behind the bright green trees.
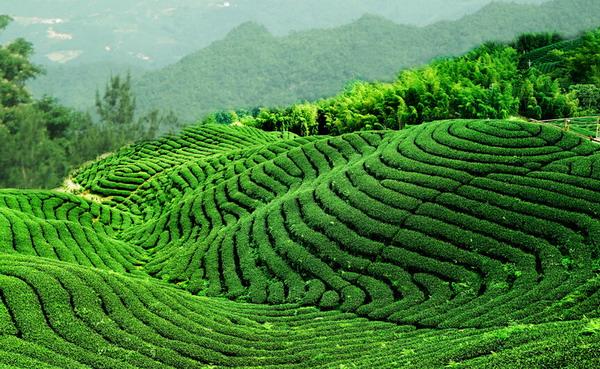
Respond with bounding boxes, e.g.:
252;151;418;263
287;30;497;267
135;0;600;120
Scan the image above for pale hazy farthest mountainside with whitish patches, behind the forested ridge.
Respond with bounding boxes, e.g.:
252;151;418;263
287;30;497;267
0;0;544;68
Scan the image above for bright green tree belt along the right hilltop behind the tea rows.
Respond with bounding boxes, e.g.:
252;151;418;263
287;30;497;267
204;29;600;135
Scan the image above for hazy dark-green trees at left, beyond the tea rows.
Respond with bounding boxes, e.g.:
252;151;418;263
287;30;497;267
0;16;176;188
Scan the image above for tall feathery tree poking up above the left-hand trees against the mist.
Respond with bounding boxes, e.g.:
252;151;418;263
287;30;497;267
96;73;135;126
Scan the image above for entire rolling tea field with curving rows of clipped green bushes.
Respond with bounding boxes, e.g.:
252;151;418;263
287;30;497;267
0;120;600;368
